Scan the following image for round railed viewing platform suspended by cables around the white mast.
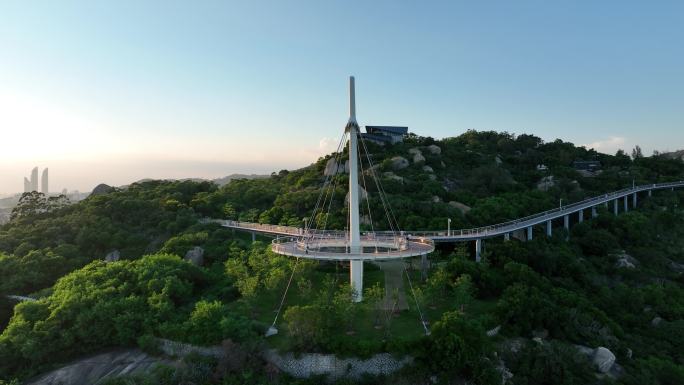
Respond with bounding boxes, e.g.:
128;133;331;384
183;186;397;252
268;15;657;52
271;233;435;261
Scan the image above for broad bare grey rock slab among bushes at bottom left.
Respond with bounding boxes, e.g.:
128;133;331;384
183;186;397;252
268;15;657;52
26;349;173;385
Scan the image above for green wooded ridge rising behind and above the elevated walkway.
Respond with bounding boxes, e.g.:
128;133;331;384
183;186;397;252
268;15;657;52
195;131;684;230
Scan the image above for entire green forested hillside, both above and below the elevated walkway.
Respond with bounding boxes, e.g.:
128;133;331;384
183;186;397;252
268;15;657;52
0;131;684;385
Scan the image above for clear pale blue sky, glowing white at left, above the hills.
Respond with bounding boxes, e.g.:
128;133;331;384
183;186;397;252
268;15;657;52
0;0;684;193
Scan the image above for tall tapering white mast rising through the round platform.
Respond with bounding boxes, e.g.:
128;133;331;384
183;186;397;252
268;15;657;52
346;76;363;302
